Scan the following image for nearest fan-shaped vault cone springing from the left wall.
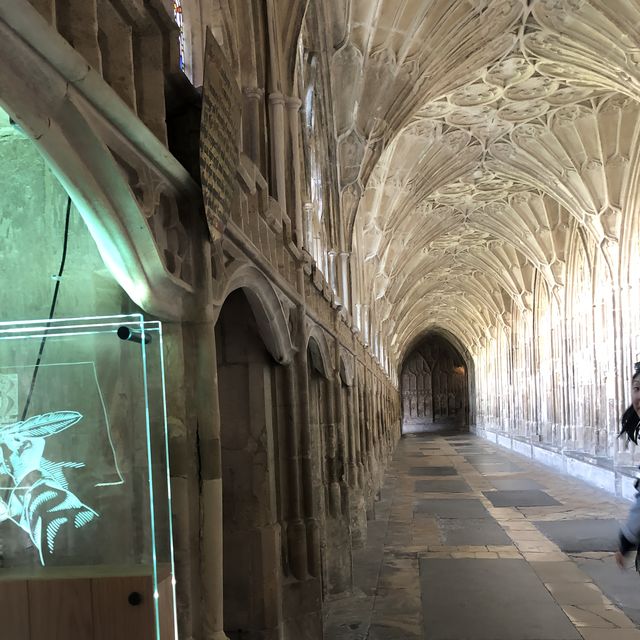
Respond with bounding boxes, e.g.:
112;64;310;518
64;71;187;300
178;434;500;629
330;0;524;238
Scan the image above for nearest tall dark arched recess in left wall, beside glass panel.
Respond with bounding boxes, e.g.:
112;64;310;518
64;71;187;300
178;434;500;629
216;290;283;640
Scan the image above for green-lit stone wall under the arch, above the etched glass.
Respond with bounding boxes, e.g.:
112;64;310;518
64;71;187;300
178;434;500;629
0;107;130;321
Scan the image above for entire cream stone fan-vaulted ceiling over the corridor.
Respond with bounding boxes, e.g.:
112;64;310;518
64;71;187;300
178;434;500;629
328;0;640;358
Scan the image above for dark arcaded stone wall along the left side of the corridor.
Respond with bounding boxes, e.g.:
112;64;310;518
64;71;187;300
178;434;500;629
0;0;400;640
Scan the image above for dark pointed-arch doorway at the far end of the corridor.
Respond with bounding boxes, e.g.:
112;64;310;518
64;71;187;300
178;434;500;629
400;333;470;434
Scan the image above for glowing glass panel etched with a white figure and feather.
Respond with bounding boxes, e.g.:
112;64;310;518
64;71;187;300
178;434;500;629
0;315;175;638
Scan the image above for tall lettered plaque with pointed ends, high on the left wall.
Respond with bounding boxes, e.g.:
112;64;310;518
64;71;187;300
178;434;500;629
200;30;242;240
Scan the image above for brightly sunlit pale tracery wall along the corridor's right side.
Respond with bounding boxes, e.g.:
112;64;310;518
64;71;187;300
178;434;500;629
476;222;640;465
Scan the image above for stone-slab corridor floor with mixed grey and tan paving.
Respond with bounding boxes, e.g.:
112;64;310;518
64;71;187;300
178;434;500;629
325;434;640;640
